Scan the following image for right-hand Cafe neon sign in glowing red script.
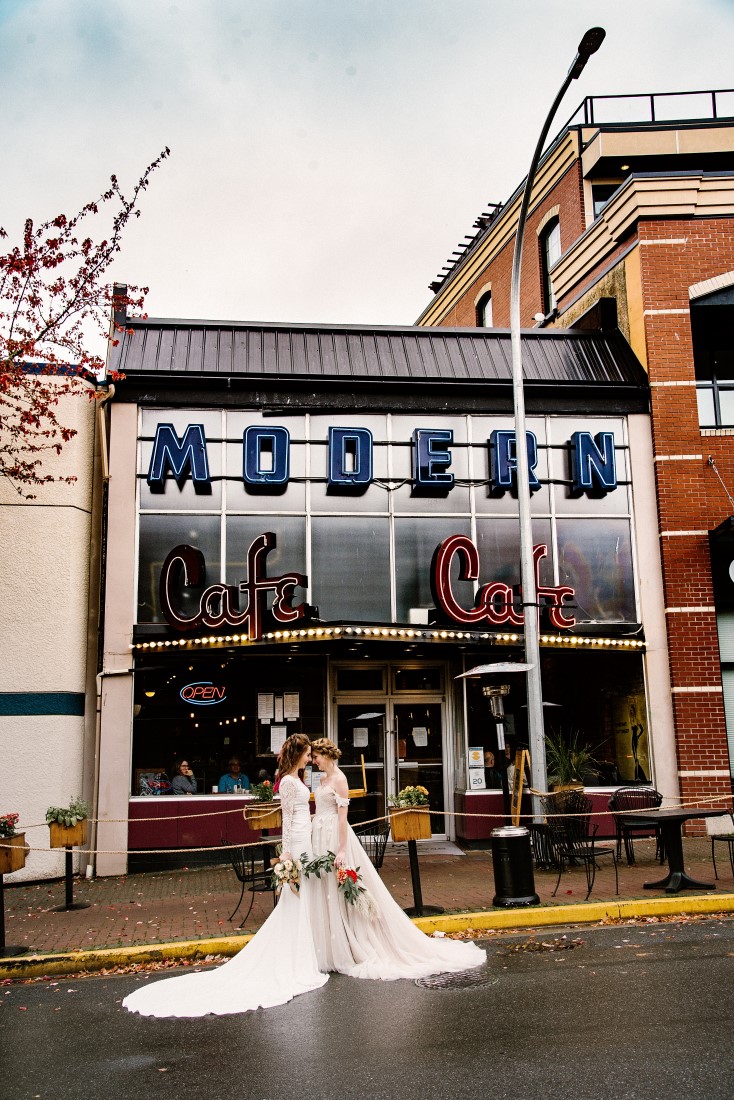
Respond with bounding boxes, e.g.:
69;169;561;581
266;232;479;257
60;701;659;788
430;535;576;629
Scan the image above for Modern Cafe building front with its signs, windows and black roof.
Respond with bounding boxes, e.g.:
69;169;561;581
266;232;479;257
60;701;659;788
96;319;676;873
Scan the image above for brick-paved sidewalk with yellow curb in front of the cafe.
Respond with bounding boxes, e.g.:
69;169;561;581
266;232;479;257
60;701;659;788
0;837;734;977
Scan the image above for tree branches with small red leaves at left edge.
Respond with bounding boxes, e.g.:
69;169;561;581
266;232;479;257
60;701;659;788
0;149;169;499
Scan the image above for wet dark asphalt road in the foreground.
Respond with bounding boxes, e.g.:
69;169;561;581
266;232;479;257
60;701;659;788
0;921;734;1100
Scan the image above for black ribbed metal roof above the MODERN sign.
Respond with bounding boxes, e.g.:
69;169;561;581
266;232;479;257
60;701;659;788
109;318;647;391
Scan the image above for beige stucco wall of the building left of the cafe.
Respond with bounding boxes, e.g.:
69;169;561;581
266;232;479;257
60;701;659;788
0;385;98;882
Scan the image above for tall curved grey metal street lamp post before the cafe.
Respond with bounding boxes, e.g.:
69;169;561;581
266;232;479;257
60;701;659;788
510;26;606;814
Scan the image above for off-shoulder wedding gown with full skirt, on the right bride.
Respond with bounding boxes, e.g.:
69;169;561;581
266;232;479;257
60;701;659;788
308;785;486;981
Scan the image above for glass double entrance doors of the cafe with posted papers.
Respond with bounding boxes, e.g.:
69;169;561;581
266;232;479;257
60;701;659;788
337;695;447;837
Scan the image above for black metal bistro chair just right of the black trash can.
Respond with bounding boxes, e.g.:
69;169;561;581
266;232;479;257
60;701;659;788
540;791;620;900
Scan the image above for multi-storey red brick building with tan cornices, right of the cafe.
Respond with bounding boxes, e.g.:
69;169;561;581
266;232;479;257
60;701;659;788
417;91;734;801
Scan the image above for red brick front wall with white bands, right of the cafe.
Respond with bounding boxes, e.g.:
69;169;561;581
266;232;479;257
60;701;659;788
638;218;734;818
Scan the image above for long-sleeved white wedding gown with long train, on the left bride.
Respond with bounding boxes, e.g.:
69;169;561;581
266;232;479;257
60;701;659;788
122;776;328;1016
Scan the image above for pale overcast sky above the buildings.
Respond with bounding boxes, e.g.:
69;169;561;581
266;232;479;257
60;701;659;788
0;0;734;325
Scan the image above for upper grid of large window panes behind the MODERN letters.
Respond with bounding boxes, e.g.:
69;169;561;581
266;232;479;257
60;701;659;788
138;409;637;625
